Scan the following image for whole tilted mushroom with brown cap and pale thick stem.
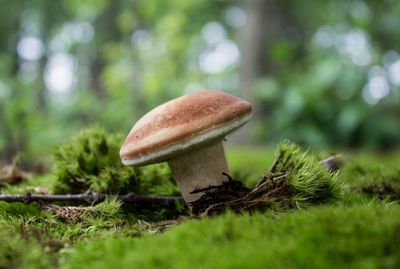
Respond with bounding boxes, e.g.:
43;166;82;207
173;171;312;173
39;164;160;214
120;90;251;204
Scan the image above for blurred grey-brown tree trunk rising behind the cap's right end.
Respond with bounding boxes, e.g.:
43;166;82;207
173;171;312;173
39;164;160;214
238;0;284;142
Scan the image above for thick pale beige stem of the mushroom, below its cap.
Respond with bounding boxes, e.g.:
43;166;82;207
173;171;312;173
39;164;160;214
168;140;228;203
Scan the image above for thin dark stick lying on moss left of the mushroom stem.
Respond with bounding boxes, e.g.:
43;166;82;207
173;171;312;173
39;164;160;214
0;192;183;207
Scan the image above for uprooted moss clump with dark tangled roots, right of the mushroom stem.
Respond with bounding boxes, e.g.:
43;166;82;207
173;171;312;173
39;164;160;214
191;141;341;215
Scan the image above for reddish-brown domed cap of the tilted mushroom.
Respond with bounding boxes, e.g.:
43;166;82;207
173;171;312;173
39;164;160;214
120;90;251;165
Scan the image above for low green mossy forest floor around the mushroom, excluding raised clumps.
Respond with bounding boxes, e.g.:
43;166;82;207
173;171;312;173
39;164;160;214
0;148;400;268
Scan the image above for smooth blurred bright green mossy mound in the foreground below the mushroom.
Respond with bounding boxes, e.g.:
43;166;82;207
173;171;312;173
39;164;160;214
61;204;400;268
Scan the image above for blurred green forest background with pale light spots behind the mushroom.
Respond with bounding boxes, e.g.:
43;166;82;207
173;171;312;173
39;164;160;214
0;0;400;162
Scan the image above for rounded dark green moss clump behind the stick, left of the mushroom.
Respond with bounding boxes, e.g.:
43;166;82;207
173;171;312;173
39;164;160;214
53;124;179;195
